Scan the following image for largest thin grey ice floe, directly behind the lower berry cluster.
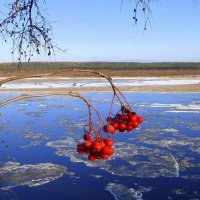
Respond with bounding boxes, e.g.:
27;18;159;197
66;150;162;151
47;138;179;178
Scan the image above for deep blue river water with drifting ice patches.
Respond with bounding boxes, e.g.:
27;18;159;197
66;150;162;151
0;93;200;200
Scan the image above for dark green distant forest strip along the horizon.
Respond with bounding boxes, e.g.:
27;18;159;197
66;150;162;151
0;62;200;72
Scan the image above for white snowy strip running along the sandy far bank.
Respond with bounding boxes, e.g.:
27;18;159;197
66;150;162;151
0;77;200;90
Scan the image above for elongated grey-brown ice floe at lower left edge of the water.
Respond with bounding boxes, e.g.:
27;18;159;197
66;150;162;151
0;162;74;190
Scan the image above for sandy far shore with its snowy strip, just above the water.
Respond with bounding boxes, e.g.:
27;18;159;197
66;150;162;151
0;75;200;92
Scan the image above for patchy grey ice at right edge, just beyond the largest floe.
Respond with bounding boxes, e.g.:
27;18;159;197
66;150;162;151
133;129;200;173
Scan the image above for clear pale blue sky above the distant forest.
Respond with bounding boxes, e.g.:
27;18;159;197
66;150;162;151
0;0;200;62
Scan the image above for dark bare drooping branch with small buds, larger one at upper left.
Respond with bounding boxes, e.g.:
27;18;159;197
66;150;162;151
0;0;61;63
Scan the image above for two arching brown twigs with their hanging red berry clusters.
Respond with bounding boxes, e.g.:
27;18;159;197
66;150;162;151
0;69;143;161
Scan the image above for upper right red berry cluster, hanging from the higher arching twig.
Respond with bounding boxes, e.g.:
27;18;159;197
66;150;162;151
103;112;143;134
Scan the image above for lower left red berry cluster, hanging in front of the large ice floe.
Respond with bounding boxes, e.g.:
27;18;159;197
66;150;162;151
77;132;114;161
